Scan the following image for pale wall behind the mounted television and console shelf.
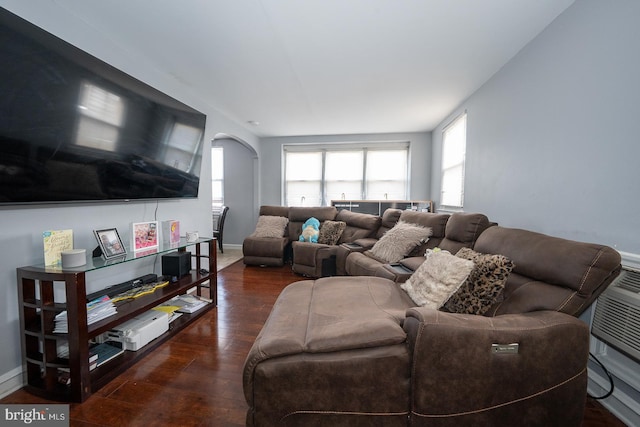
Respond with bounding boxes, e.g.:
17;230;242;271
0;0;258;395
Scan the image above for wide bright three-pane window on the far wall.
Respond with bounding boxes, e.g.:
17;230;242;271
284;142;409;206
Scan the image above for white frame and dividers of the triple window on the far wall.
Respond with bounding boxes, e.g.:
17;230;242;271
282;141;410;206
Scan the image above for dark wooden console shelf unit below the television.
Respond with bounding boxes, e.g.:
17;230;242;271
17;239;217;402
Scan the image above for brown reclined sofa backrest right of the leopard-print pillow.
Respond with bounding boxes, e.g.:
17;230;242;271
474;226;620;316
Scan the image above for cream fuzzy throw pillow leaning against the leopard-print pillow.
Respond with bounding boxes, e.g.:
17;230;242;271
400;251;475;309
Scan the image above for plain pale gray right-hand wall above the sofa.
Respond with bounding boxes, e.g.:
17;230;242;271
431;0;640;425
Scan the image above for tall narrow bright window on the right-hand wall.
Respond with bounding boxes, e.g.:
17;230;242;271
440;113;467;208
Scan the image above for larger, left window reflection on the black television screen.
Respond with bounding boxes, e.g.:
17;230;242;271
76;82;125;151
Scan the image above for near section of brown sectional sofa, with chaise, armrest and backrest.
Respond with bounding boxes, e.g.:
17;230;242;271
243;206;620;427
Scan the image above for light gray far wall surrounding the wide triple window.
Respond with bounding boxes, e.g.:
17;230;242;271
259;132;431;205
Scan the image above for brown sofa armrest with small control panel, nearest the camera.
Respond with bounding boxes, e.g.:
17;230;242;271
403;308;589;426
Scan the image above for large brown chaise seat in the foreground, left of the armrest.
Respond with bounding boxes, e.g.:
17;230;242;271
243;277;413;427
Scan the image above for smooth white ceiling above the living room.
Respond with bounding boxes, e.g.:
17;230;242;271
28;0;574;136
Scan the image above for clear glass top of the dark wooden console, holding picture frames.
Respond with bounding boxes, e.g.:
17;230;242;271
23;237;213;274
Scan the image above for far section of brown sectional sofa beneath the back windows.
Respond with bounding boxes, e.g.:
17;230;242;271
243;205;493;282
